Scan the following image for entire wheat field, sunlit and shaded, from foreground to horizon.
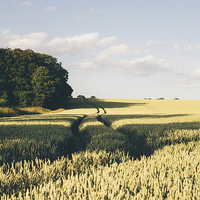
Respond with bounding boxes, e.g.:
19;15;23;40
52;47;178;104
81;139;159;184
0;99;200;200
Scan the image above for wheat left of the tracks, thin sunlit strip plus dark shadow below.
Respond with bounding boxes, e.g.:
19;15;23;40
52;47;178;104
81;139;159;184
0;115;84;166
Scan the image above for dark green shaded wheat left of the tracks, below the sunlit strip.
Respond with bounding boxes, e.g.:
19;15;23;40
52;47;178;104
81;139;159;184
0;125;73;165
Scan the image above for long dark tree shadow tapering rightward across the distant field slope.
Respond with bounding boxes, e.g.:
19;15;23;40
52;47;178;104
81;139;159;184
67;98;145;109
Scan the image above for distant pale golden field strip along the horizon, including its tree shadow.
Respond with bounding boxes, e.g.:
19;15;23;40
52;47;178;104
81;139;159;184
64;98;200;115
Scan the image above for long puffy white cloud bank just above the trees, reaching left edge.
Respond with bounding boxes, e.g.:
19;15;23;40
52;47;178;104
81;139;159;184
0;29;117;55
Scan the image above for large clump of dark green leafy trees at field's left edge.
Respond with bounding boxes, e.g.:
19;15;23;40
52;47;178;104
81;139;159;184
0;48;73;109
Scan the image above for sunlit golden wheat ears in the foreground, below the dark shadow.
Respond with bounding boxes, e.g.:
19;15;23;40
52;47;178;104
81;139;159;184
0;142;200;200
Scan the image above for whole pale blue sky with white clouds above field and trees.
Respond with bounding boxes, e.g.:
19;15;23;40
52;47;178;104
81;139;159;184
0;0;200;100
